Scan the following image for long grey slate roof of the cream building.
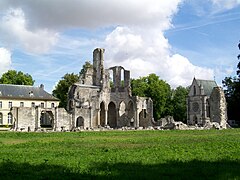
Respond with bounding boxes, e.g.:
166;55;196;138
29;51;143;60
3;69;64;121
0;84;58;101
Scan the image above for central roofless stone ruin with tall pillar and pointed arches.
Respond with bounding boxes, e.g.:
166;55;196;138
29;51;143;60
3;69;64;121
68;48;153;128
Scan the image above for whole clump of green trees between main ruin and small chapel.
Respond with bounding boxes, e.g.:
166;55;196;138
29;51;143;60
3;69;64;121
131;74;188;122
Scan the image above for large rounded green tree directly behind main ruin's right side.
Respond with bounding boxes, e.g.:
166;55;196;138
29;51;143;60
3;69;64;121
131;74;171;120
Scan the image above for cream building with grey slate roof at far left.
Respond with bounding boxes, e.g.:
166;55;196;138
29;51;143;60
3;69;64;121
0;84;62;129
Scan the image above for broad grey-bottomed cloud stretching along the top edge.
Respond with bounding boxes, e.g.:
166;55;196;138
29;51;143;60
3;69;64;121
0;0;181;28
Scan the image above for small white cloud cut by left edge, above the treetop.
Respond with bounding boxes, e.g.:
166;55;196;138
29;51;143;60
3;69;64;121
0;48;12;76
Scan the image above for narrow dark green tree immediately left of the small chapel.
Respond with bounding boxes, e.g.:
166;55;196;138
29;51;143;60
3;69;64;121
172;86;189;123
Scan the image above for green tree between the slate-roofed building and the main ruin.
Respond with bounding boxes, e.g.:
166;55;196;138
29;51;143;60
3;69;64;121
53;73;79;109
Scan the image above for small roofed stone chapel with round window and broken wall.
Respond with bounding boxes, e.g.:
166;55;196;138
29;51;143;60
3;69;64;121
187;78;227;128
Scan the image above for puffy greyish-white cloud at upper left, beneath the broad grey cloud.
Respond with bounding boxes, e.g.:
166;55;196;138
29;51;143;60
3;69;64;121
0;9;58;53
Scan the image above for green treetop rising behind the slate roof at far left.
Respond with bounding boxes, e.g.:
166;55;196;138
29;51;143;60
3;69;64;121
0;70;35;86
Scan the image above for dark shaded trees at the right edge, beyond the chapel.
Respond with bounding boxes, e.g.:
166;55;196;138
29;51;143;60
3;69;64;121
222;43;240;120
